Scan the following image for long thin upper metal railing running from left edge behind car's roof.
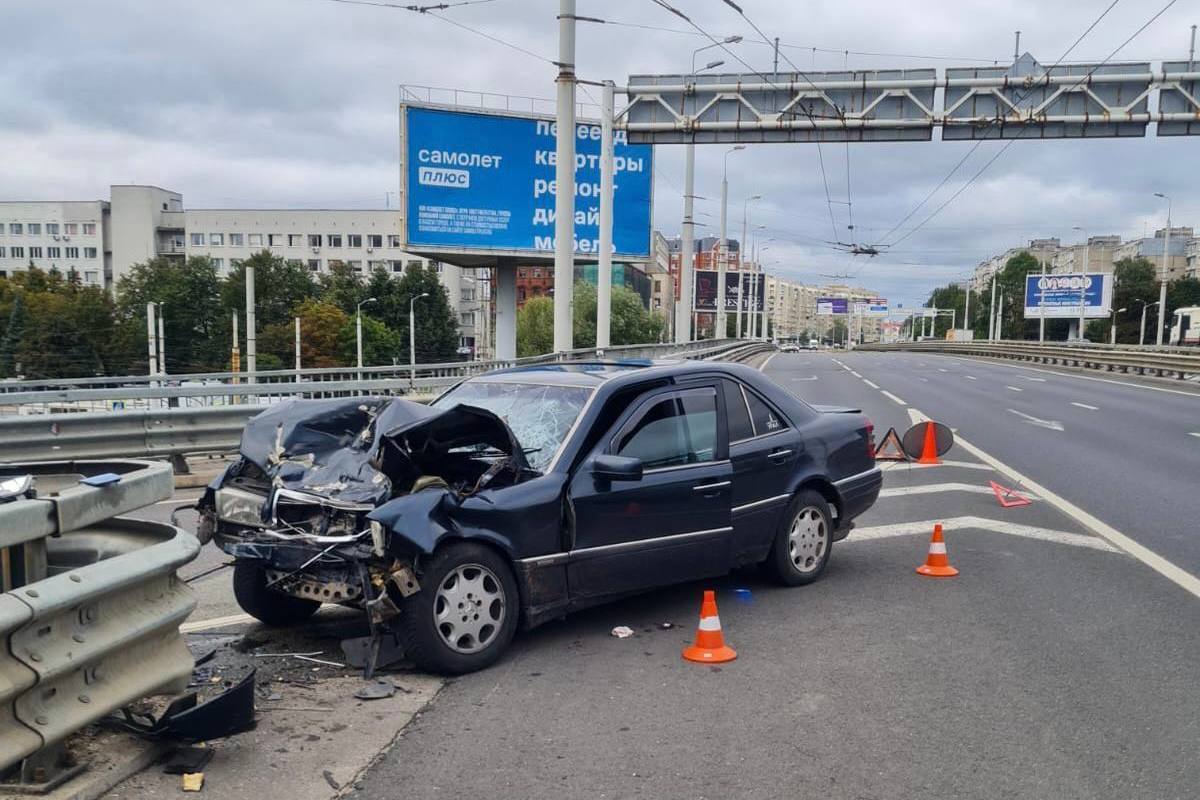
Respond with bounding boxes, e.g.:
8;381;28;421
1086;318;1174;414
0;339;745;416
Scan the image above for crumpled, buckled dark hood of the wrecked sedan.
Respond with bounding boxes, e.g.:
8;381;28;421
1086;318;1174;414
239;397;527;505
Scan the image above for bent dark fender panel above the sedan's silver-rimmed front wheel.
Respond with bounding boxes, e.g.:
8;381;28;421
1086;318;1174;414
367;487;511;559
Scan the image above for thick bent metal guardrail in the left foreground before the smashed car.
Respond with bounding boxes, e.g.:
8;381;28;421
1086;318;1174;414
0;461;199;772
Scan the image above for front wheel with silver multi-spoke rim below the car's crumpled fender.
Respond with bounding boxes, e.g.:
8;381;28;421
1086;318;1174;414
396;542;520;675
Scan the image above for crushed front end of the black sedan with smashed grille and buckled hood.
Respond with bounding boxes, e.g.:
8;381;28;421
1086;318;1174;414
198;397;539;657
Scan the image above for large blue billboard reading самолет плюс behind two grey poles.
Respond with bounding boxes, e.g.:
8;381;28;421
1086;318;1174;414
401;106;653;258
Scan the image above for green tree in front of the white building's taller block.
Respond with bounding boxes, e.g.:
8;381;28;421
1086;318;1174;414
114;257;230;373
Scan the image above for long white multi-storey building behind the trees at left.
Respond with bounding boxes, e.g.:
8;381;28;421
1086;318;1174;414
0;185;491;349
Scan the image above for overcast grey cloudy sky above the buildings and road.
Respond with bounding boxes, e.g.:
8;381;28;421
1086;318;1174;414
0;0;1200;305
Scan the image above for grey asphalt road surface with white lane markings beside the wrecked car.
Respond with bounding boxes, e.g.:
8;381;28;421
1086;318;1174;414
338;353;1200;800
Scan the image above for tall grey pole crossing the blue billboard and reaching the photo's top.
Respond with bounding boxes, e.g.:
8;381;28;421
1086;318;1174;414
552;0;575;353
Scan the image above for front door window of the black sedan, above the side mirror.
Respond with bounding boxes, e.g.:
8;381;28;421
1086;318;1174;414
616;392;716;469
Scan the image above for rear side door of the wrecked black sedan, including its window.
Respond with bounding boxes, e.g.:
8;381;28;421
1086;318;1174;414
722;379;804;564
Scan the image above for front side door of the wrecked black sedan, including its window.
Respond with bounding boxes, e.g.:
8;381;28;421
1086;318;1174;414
568;380;732;603
